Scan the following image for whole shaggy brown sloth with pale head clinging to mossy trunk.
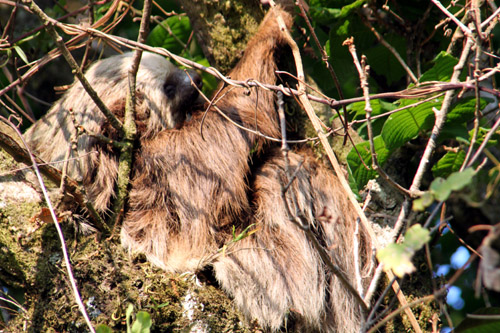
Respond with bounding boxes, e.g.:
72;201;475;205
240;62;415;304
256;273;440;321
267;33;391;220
27;8;370;332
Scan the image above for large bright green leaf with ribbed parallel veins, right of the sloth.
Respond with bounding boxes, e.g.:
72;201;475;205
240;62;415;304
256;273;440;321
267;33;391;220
381;101;440;150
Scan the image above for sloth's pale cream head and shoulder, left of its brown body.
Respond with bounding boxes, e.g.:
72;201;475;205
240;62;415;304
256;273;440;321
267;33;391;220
24;52;202;212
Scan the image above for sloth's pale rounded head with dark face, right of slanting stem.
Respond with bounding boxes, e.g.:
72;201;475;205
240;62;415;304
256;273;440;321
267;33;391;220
81;52;202;136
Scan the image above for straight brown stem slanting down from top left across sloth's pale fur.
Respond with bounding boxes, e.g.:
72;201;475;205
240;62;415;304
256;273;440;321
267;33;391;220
23;0;123;135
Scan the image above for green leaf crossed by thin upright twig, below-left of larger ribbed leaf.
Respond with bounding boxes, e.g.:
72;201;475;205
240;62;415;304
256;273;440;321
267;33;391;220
347;136;390;189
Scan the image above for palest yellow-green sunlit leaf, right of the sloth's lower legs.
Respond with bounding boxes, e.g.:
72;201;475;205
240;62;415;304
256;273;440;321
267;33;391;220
377;243;415;277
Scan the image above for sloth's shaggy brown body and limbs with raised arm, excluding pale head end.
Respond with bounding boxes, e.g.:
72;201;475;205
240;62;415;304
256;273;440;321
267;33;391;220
122;8;372;332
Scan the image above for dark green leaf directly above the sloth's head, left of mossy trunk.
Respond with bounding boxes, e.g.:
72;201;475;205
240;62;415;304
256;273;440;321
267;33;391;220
147;16;192;54
